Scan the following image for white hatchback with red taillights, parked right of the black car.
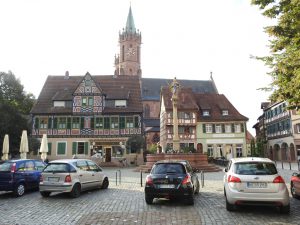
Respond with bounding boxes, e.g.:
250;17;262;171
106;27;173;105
224;157;290;213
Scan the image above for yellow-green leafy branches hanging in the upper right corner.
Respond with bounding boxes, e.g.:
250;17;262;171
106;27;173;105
252;0;300;109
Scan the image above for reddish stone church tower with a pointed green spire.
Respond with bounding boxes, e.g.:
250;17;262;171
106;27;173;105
115;6;142;77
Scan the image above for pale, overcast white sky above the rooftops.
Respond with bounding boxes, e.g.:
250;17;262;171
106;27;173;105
0;0;271;135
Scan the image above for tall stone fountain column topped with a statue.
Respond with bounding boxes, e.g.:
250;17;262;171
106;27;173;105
171;77;179;152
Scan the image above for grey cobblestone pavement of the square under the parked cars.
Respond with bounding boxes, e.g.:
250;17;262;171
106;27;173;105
0;165;300;225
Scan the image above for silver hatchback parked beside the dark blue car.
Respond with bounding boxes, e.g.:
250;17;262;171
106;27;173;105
40;159;109;198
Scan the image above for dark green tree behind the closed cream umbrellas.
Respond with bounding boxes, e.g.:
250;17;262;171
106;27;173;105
0;72;35;155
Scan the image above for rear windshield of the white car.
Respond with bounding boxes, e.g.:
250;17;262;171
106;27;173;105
234;162;277;175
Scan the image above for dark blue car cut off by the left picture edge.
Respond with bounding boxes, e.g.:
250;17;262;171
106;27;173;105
0;159;46;197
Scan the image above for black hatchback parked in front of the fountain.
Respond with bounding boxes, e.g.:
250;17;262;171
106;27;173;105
145;160;200;205
